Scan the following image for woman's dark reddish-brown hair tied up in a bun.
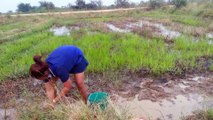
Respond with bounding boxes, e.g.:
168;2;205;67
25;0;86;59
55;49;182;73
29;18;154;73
29;55;49;79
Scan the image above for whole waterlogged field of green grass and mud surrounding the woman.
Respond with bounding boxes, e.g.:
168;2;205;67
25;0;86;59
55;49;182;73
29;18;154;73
0;4;213;120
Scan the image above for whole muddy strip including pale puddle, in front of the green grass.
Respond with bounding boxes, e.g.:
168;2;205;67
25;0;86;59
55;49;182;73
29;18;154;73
0;71;213;120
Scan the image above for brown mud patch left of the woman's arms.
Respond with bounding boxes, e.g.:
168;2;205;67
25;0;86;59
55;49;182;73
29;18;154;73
0;78;45;109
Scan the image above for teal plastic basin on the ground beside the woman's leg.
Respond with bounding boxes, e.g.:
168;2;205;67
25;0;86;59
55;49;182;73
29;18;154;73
88;92;109;110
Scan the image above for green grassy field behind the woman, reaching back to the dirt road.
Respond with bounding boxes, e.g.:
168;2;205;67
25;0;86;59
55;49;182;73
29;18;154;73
0;1;213;120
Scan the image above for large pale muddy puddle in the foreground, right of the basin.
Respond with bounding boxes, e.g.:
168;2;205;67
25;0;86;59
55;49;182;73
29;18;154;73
115;94;213;120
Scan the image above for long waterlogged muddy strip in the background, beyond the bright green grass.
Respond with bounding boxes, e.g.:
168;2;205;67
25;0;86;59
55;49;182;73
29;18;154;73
106;20;181;39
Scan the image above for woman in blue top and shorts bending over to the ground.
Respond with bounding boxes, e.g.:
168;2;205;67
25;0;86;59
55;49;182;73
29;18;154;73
30;45;88;103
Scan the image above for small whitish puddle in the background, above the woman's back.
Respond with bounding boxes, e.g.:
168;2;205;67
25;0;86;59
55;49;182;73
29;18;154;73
50;26;70;36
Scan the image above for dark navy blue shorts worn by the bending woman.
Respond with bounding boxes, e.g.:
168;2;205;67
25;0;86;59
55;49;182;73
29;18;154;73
70;57;89;74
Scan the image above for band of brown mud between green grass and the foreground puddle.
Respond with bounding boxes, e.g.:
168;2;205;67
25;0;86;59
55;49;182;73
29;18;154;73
0;69;213;107
